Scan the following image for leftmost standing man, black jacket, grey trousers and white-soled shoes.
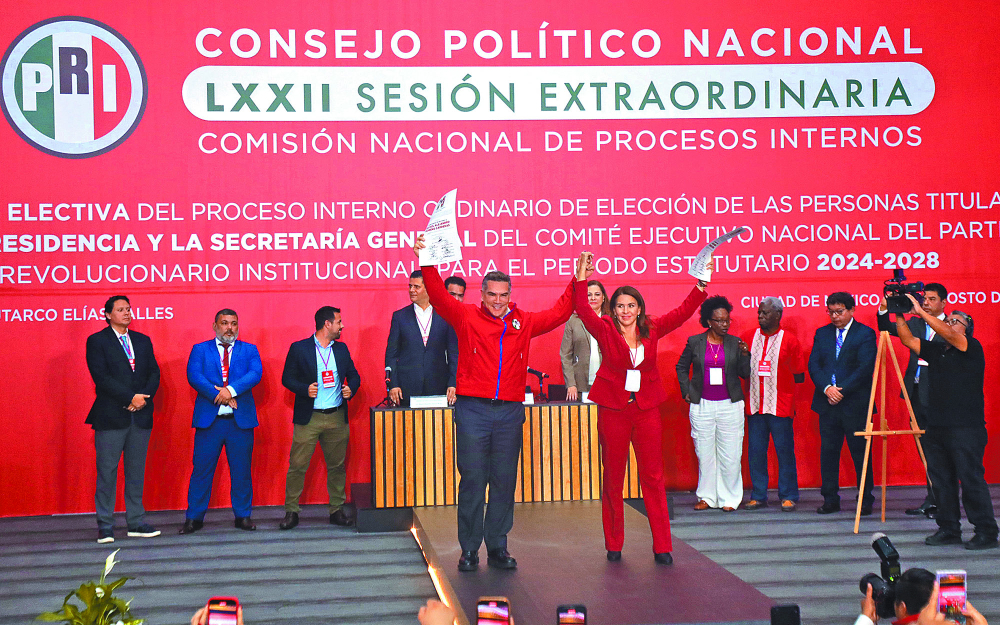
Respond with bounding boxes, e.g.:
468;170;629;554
86;295;160;543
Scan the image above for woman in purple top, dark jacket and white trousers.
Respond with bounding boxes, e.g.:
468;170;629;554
677;295;750;512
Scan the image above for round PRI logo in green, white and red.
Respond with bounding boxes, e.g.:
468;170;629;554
0;17;147;158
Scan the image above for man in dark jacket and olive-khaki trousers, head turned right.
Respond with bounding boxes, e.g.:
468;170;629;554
278;306;361;530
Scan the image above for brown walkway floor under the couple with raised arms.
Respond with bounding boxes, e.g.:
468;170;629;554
414;501;772;625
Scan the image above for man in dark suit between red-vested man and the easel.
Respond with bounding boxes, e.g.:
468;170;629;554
809;292;878;515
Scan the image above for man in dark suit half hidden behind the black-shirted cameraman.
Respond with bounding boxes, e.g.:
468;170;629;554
878;282;948;518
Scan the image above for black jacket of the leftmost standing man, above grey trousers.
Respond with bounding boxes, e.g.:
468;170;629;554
86;326;160;430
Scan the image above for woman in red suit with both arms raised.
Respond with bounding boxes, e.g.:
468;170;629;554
574;252;707;564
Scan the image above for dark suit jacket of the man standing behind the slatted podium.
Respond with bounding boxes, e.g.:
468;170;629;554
385;304;458;404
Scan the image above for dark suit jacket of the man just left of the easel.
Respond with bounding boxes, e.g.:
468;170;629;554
809;318;878;420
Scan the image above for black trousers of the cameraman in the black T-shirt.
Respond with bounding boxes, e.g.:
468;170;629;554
920;425;997;538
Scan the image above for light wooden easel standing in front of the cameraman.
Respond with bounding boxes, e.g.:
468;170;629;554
854;330;927;534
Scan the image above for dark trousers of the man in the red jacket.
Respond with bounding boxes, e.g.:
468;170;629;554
455;396;524;551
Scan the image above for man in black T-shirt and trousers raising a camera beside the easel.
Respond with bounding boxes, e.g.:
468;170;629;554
882;294;997;549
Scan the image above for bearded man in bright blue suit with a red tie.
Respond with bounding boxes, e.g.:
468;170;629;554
179;308;264;534
